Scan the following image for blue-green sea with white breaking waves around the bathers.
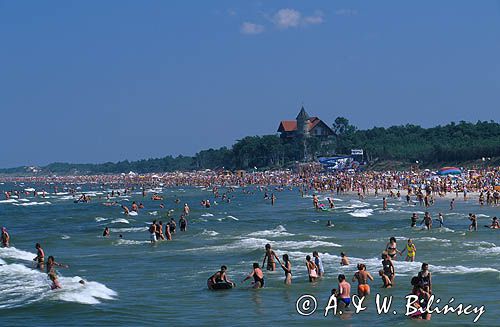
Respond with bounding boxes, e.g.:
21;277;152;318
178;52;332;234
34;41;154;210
0;183;500;326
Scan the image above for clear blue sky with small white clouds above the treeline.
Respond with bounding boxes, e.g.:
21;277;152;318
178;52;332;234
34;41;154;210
0;0;500;167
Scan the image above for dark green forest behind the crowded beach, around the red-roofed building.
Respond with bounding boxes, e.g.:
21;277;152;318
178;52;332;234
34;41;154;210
0;117;500;174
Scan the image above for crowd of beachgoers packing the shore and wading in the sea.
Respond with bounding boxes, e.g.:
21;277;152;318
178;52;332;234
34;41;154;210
1;168;500;319
